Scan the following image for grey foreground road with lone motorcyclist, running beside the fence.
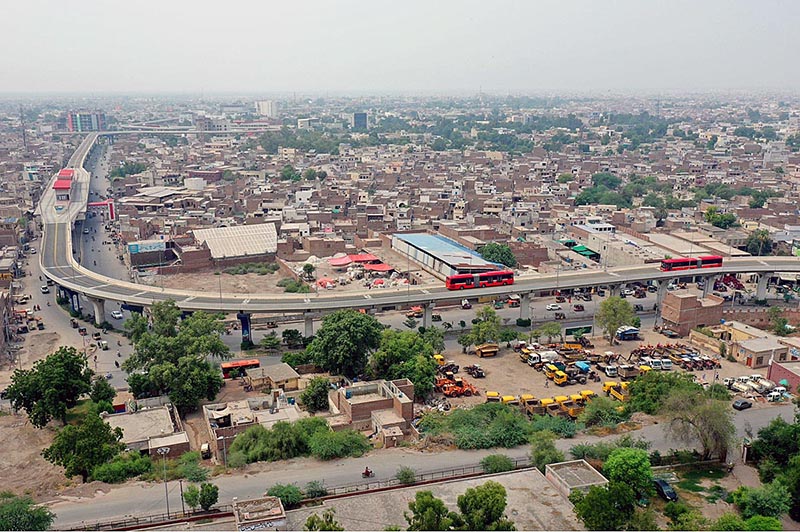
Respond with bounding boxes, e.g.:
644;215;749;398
49;405;794;528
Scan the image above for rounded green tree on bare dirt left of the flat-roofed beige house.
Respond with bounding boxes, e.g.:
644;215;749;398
42;413;125;482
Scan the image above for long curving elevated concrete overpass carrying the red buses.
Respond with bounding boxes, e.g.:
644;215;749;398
39;133;800;336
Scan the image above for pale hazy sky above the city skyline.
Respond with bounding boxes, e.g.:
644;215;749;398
0;0;800;94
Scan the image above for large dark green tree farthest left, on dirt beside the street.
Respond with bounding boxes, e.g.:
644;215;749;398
6;347;93;428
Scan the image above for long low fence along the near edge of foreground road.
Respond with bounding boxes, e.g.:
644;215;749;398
63;457;531;530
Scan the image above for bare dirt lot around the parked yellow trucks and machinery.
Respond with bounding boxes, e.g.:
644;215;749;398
434;331;780;405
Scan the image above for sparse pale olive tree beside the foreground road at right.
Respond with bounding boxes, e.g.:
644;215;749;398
660;389;736;460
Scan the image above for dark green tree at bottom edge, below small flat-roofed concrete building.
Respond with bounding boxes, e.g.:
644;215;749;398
569;482;636;530
